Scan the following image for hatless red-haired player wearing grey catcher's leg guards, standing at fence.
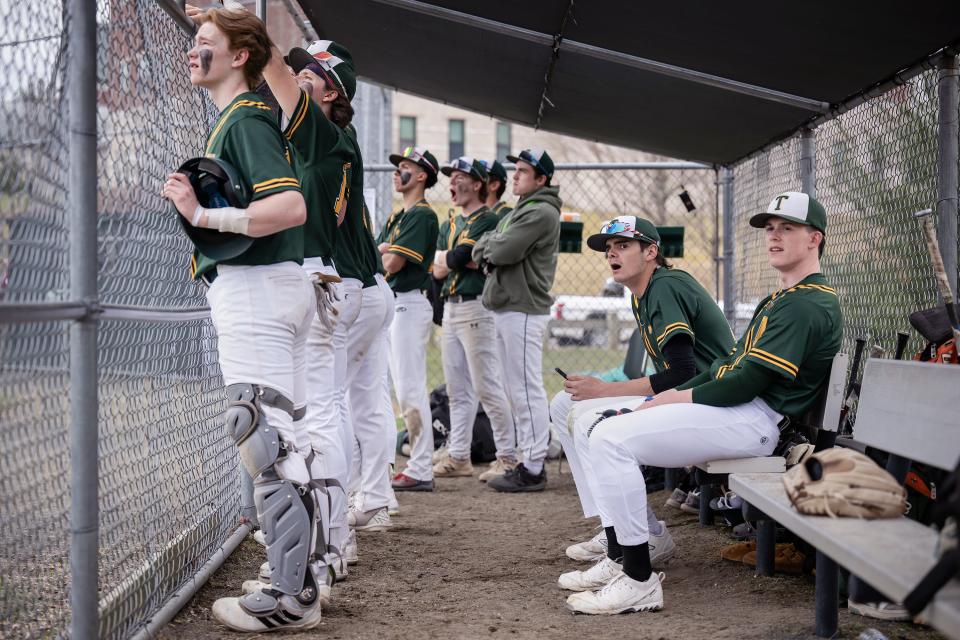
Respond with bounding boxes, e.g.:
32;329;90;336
163;9;318;632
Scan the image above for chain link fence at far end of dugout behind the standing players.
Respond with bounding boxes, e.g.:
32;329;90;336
366;162;719;404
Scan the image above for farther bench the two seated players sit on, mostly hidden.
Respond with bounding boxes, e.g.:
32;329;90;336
696;353;849;528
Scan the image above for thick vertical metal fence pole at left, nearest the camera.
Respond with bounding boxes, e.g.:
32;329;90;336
66;0;99;638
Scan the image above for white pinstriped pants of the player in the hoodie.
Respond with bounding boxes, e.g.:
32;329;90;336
496;311;550;473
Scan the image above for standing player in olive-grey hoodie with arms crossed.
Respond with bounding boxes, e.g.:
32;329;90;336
473;149;562;493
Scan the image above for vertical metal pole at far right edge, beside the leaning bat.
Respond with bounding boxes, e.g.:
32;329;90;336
937;55;960;298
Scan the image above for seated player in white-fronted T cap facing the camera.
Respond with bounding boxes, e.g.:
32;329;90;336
567;191;842;614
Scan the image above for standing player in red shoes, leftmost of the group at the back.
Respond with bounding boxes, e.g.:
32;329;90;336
377;147;440;491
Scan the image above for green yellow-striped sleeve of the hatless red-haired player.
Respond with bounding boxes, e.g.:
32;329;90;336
223;118;300;201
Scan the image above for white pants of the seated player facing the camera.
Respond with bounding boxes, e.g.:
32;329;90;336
574;398;783;545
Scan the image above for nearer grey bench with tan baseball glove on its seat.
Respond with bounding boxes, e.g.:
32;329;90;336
730;359;960;638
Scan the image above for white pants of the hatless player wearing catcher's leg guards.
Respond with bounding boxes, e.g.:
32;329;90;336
207;262;316;484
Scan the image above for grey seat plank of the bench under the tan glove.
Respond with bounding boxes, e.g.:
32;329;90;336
730;473;960;638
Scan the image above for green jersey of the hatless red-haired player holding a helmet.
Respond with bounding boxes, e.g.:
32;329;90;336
190;92;303;278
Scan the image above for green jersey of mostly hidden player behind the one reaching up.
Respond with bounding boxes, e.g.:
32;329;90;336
333;125;383;287
